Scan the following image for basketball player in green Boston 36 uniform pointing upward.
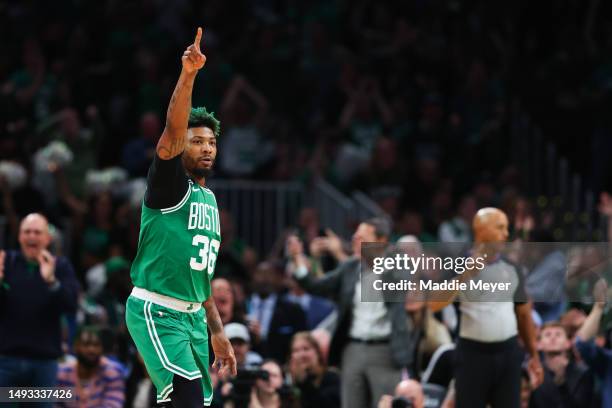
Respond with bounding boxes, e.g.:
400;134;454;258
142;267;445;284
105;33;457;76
126;28;236;408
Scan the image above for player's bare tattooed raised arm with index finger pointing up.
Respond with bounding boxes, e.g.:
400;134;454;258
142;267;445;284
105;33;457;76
157;27;206;160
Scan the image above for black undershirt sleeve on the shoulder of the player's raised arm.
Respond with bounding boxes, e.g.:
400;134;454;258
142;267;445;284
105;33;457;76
145;154;189;209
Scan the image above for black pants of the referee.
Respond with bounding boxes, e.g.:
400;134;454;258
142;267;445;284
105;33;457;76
455;336;524;408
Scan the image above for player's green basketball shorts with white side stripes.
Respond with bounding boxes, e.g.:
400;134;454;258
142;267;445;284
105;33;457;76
125;291;213;406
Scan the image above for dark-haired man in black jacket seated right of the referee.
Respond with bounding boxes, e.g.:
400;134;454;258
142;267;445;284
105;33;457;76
530;322;594;408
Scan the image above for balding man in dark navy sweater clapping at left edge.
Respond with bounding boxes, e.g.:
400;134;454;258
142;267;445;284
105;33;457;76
0;214;79;404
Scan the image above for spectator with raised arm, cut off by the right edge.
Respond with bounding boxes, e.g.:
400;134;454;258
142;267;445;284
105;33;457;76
575;280;612;407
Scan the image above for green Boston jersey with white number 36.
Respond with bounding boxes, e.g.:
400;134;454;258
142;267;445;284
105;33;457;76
131;158;221;303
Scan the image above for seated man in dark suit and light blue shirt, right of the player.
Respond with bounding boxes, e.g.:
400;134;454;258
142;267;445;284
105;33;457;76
248;262;306;364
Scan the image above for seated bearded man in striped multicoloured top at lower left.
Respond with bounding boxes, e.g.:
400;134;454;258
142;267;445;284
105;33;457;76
57;326;125;408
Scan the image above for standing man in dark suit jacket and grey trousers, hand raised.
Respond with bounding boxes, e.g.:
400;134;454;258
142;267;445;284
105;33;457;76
289;218;416;408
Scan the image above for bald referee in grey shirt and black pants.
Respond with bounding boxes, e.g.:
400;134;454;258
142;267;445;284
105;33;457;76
430;208;543;408
